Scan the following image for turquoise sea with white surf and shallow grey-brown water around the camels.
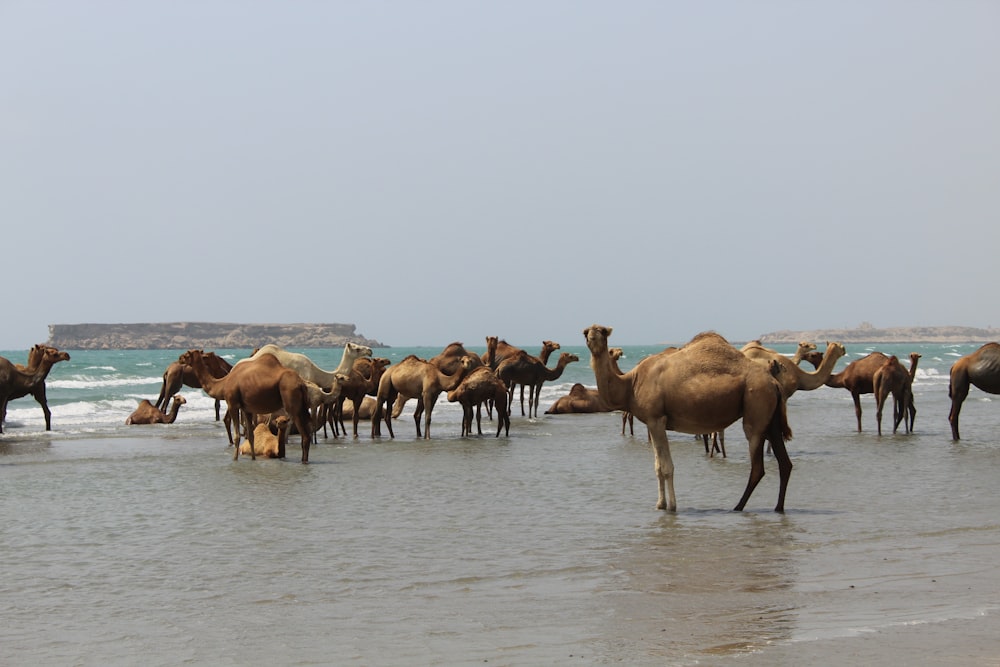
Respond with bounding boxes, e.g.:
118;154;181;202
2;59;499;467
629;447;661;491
0;337;1000;665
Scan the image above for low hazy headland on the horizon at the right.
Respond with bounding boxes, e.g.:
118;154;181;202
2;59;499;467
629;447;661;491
759;322;1000;345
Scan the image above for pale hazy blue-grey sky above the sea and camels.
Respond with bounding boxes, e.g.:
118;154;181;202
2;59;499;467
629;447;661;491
0;0;1000;350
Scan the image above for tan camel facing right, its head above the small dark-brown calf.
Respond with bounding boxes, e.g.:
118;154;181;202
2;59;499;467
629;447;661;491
372;354;474;440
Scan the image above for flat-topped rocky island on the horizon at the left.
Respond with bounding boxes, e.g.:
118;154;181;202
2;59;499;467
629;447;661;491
49;322;388;350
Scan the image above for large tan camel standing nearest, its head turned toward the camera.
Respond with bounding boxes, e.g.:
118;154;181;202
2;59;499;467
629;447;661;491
583;324;792;512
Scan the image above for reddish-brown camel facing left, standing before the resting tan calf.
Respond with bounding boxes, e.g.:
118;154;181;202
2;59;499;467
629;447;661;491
182;350;312;463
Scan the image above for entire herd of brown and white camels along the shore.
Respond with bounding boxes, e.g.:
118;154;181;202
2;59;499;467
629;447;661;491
0;336;1000;512
